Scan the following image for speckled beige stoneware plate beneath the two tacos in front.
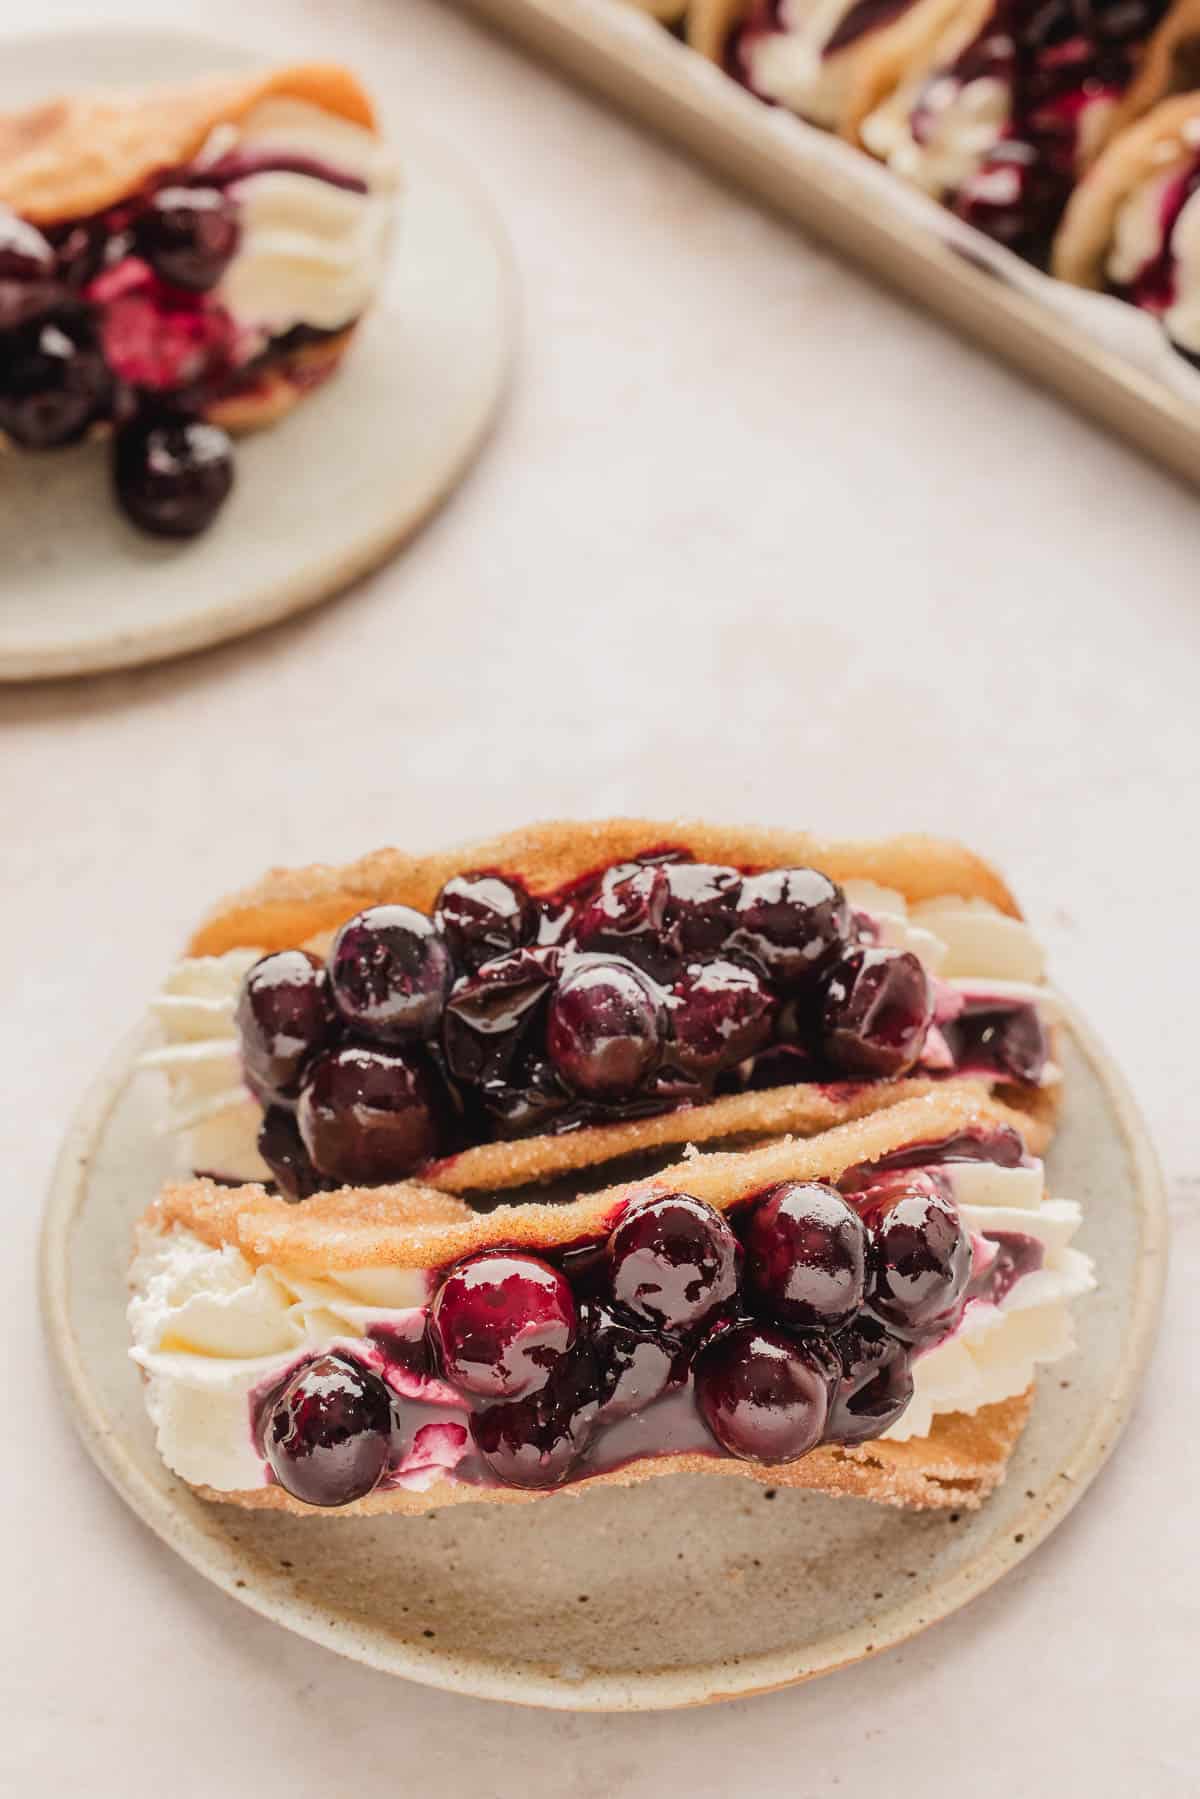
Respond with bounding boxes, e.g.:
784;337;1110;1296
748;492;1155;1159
41;1020;1166;1711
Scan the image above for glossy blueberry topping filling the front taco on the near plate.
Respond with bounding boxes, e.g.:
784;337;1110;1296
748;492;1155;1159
250;1135;1043;1506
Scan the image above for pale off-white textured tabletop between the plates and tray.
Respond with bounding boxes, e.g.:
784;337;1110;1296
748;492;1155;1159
0;0;1200;1799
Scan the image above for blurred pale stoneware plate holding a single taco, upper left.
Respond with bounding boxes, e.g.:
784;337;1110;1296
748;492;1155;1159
0;27;516;680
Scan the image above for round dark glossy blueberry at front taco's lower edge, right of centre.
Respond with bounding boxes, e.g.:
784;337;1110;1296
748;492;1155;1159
696;1324;829;1463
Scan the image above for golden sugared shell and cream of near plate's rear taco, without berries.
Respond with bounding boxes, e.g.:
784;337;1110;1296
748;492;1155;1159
146;819;1058;1216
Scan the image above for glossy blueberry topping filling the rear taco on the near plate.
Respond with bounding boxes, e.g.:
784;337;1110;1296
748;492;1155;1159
237;846;1047;1196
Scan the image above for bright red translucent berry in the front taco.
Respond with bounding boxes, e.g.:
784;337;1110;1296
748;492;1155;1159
430;1250;578;1400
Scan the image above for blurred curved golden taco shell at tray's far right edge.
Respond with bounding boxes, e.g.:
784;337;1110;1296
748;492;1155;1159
1052;89;1200;288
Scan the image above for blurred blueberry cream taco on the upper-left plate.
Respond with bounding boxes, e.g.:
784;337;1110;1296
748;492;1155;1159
0;65;398;536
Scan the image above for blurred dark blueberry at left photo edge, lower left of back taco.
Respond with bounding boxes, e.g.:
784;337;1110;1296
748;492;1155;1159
0;306;112;450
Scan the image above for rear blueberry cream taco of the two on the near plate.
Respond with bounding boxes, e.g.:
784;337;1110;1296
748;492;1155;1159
138;819;1058;1198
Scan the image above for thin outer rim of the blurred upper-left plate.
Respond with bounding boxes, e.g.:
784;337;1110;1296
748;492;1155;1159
0;22;522;685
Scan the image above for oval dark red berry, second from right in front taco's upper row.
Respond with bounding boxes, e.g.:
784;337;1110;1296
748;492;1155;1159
745;1180;867;1331
